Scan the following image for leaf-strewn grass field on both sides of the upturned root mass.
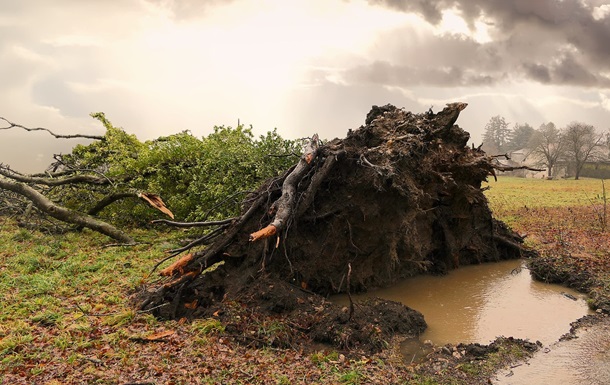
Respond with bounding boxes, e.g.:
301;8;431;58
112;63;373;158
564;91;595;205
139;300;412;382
0;177;610;385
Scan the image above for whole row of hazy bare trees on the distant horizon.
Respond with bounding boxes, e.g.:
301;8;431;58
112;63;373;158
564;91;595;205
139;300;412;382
483;115;610;179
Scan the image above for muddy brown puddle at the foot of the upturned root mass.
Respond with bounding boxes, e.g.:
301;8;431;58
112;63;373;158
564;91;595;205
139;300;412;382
334;260;591;352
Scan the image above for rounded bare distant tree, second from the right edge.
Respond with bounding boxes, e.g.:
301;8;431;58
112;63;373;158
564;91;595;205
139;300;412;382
529;122;566;178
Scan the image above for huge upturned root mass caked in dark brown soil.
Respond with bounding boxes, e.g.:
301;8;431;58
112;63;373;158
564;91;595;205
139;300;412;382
139;103;527;350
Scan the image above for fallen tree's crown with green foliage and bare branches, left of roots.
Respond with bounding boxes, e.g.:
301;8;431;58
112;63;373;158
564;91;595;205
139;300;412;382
0;113;296;243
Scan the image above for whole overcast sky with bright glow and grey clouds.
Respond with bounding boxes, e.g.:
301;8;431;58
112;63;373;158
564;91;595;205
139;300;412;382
0;0;610;172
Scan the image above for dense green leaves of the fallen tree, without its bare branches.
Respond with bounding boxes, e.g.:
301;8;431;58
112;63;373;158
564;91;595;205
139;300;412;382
53;113;298;224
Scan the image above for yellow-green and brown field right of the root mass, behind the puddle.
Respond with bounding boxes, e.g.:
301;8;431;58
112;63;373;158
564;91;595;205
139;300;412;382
485;177;610;311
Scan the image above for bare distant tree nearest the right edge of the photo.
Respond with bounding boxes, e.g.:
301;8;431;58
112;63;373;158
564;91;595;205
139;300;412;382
562;122;604;179
